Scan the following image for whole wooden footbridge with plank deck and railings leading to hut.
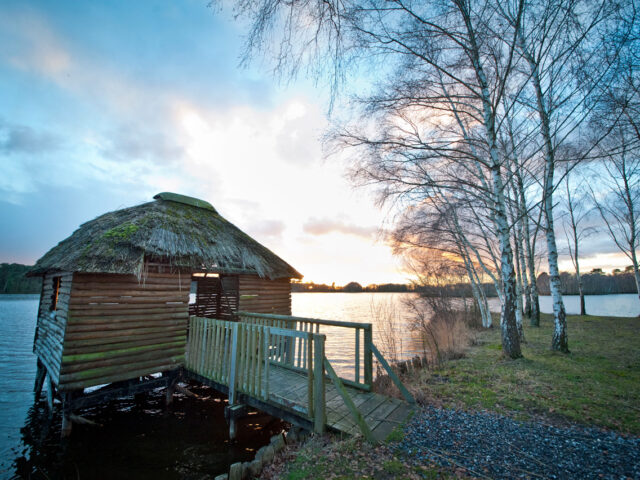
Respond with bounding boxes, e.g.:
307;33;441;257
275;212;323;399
185;312;414;441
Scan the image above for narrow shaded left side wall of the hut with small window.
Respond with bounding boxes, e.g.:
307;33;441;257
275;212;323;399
33;272;73;384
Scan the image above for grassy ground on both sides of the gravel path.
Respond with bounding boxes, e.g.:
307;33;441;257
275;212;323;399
262;315;640;480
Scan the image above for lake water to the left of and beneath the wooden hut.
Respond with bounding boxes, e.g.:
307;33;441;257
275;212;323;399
0;295;284;480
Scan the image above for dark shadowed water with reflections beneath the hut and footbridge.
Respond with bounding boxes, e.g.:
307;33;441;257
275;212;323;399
8;384;285;480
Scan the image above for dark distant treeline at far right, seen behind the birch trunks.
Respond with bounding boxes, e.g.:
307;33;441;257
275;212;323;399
538;271;637;295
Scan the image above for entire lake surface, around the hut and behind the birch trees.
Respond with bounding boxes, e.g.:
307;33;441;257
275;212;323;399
0;293;640;479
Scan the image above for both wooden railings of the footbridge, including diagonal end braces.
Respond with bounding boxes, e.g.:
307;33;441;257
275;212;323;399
185;312;415;440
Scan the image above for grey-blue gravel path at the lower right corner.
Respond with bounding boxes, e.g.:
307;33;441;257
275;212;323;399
396;407;640;480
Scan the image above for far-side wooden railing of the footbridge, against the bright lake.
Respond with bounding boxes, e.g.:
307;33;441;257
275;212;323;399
236;312;373;391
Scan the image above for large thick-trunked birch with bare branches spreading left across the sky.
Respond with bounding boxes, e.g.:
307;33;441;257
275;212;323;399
238;0;523;358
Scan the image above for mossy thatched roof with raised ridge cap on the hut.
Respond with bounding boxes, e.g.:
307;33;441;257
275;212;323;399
32;192;302;279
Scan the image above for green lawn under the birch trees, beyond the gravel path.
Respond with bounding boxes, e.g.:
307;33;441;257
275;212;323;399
403;315;640;434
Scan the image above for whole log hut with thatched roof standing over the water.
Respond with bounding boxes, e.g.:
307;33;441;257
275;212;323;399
31;192;301;422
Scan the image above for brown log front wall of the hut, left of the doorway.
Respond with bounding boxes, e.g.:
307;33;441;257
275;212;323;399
59;273;191;390
